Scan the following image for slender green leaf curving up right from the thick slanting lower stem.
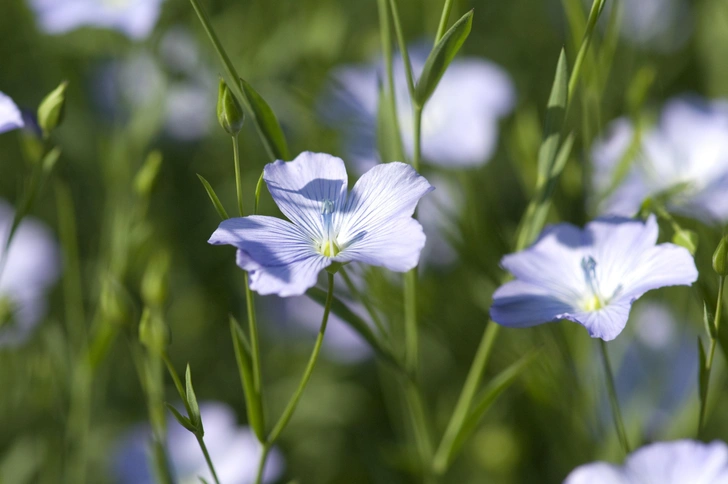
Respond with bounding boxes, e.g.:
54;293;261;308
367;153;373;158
440;351;540;467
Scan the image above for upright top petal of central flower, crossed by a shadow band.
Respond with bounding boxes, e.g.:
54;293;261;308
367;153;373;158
263;151;348;240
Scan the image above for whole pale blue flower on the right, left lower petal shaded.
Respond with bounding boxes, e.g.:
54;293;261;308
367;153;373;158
490;216;698;341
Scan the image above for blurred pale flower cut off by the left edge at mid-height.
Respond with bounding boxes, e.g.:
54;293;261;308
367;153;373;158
0;200;60;346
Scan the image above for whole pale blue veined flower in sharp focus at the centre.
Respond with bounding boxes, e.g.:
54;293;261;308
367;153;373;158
209;152;433;297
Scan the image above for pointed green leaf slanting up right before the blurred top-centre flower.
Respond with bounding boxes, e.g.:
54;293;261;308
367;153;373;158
414;10;473;107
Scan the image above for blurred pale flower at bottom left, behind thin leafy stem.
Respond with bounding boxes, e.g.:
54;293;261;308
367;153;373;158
116;402;284;484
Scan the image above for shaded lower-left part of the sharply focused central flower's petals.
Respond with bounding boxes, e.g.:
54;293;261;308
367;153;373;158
209;215;331;297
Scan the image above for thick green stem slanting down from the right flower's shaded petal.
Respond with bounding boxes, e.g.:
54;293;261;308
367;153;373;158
433;321;500;474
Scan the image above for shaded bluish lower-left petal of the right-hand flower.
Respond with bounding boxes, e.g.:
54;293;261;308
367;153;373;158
490;281;575;328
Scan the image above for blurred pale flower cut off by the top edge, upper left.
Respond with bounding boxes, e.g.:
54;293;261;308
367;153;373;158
30;0;163;40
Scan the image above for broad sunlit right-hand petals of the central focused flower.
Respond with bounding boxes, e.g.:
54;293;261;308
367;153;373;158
336;162;433;272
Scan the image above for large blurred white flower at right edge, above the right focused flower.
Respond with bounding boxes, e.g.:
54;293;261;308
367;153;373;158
592;98;728;222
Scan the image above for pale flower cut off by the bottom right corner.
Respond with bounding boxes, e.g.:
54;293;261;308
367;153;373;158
564;440;728;484
